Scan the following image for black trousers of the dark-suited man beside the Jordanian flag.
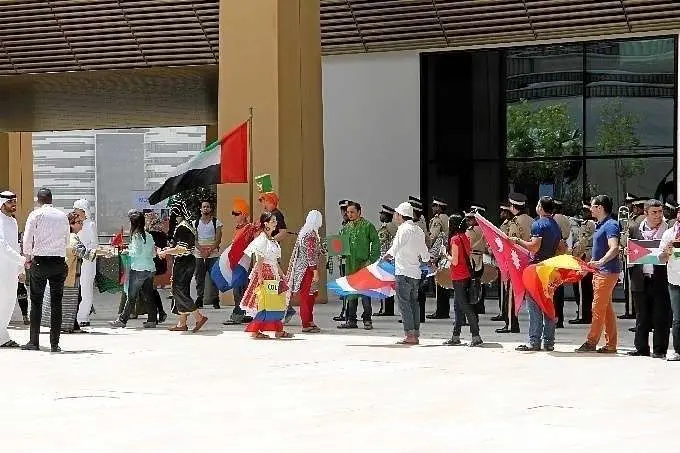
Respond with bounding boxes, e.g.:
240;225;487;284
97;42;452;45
633;277;673;354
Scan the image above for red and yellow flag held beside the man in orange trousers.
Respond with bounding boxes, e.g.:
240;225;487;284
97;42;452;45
522;255;593;321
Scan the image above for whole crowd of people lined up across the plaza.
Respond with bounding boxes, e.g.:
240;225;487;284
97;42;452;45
0;184;680;361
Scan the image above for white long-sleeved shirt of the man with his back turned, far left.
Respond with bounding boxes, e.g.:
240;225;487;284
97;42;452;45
24;204;71;257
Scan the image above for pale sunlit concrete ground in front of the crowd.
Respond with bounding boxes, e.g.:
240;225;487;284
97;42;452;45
0;295;680;453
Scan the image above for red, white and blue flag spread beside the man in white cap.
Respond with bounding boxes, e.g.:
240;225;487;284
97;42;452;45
328;260;396;299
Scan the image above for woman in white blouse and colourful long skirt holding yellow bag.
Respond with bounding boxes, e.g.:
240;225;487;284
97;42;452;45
241;212;293;340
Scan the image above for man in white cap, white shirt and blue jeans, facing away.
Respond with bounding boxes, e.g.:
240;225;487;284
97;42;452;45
387;203;430;345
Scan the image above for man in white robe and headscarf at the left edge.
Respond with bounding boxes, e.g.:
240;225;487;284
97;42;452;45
0;191;26;348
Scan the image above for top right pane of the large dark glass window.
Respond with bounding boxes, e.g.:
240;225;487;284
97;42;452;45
585;38;676;155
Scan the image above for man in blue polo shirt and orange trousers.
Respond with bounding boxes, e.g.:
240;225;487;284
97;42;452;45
576;195;621;354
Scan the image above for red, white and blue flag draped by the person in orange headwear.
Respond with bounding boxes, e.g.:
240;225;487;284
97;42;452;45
210;224;257;292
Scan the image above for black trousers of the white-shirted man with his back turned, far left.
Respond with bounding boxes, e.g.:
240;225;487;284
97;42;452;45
29;256;68;347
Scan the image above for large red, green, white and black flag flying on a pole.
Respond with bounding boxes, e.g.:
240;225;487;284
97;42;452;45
149;121;248;205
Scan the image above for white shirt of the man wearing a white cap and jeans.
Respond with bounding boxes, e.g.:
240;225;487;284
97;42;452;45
387;220;430;280
